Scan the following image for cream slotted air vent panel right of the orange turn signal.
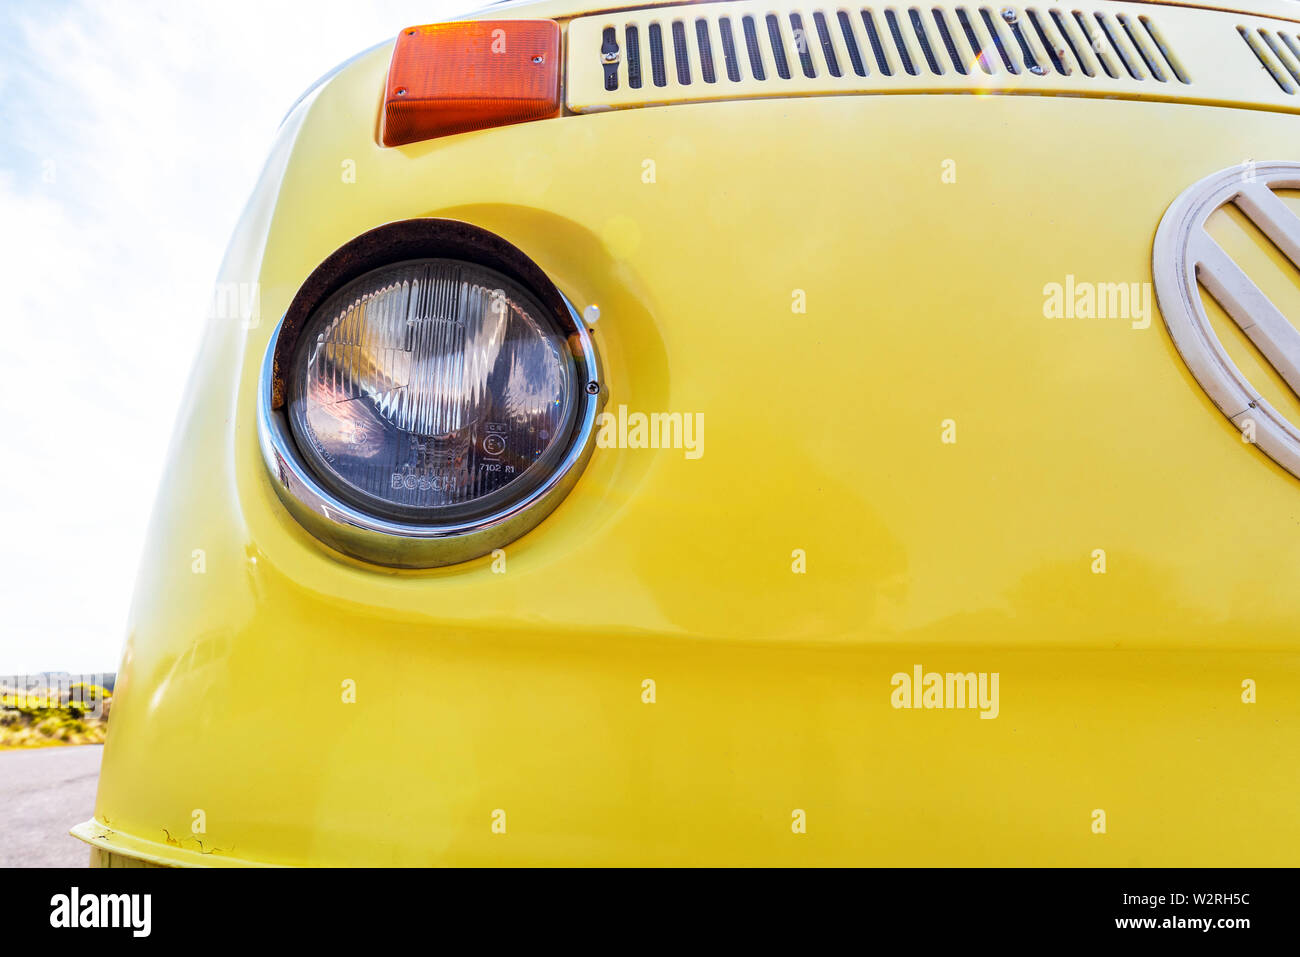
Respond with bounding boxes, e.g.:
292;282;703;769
567;0;1300;112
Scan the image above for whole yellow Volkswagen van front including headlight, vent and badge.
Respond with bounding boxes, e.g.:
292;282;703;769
74;0;1300;866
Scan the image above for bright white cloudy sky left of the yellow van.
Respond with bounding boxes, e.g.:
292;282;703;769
0;0;470;675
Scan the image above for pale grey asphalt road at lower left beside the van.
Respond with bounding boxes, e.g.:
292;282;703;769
0;744;104;867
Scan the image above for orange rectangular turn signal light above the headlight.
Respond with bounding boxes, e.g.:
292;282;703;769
381;20;560;146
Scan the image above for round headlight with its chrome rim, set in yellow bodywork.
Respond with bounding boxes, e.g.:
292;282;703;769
261;221;601;567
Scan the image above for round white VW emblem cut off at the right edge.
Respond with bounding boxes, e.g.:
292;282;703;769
1152;163;1300;477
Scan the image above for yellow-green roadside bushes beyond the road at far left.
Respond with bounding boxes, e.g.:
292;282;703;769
0;681;113;749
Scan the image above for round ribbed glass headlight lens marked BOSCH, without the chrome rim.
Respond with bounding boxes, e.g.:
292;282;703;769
287;259;585;524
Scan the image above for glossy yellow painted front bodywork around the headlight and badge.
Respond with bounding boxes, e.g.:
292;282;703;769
78;5;1300;866
